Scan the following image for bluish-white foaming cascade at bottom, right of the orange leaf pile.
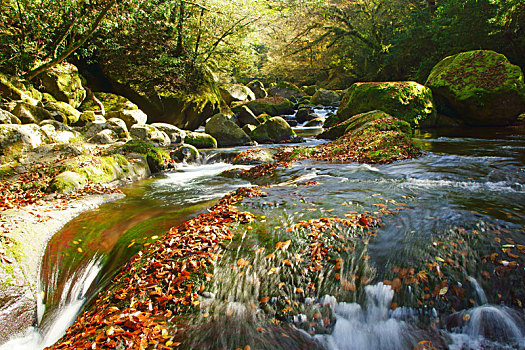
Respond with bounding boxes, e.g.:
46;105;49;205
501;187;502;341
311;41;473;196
316;283;413;350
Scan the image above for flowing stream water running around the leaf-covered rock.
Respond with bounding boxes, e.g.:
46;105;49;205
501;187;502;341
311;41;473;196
0;114;525;350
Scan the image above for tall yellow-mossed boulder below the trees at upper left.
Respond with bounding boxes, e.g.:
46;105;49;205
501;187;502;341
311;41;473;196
40;62;86;108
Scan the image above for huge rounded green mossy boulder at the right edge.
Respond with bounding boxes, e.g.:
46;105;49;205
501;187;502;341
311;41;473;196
426;50;525;126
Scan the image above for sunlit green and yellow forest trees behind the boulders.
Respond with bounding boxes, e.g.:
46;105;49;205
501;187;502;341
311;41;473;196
0;0;525;89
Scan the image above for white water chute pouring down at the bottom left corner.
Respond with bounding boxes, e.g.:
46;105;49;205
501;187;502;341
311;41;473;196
0;256;102;350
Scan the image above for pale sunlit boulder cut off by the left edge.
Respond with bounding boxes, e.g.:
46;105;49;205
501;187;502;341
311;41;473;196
0;124;52;160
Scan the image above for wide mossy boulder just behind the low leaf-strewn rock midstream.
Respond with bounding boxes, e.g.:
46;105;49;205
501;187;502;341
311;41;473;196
332;81;437;127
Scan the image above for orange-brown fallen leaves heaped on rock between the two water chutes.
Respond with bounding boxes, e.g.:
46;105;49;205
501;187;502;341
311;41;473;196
51;189;262;349
